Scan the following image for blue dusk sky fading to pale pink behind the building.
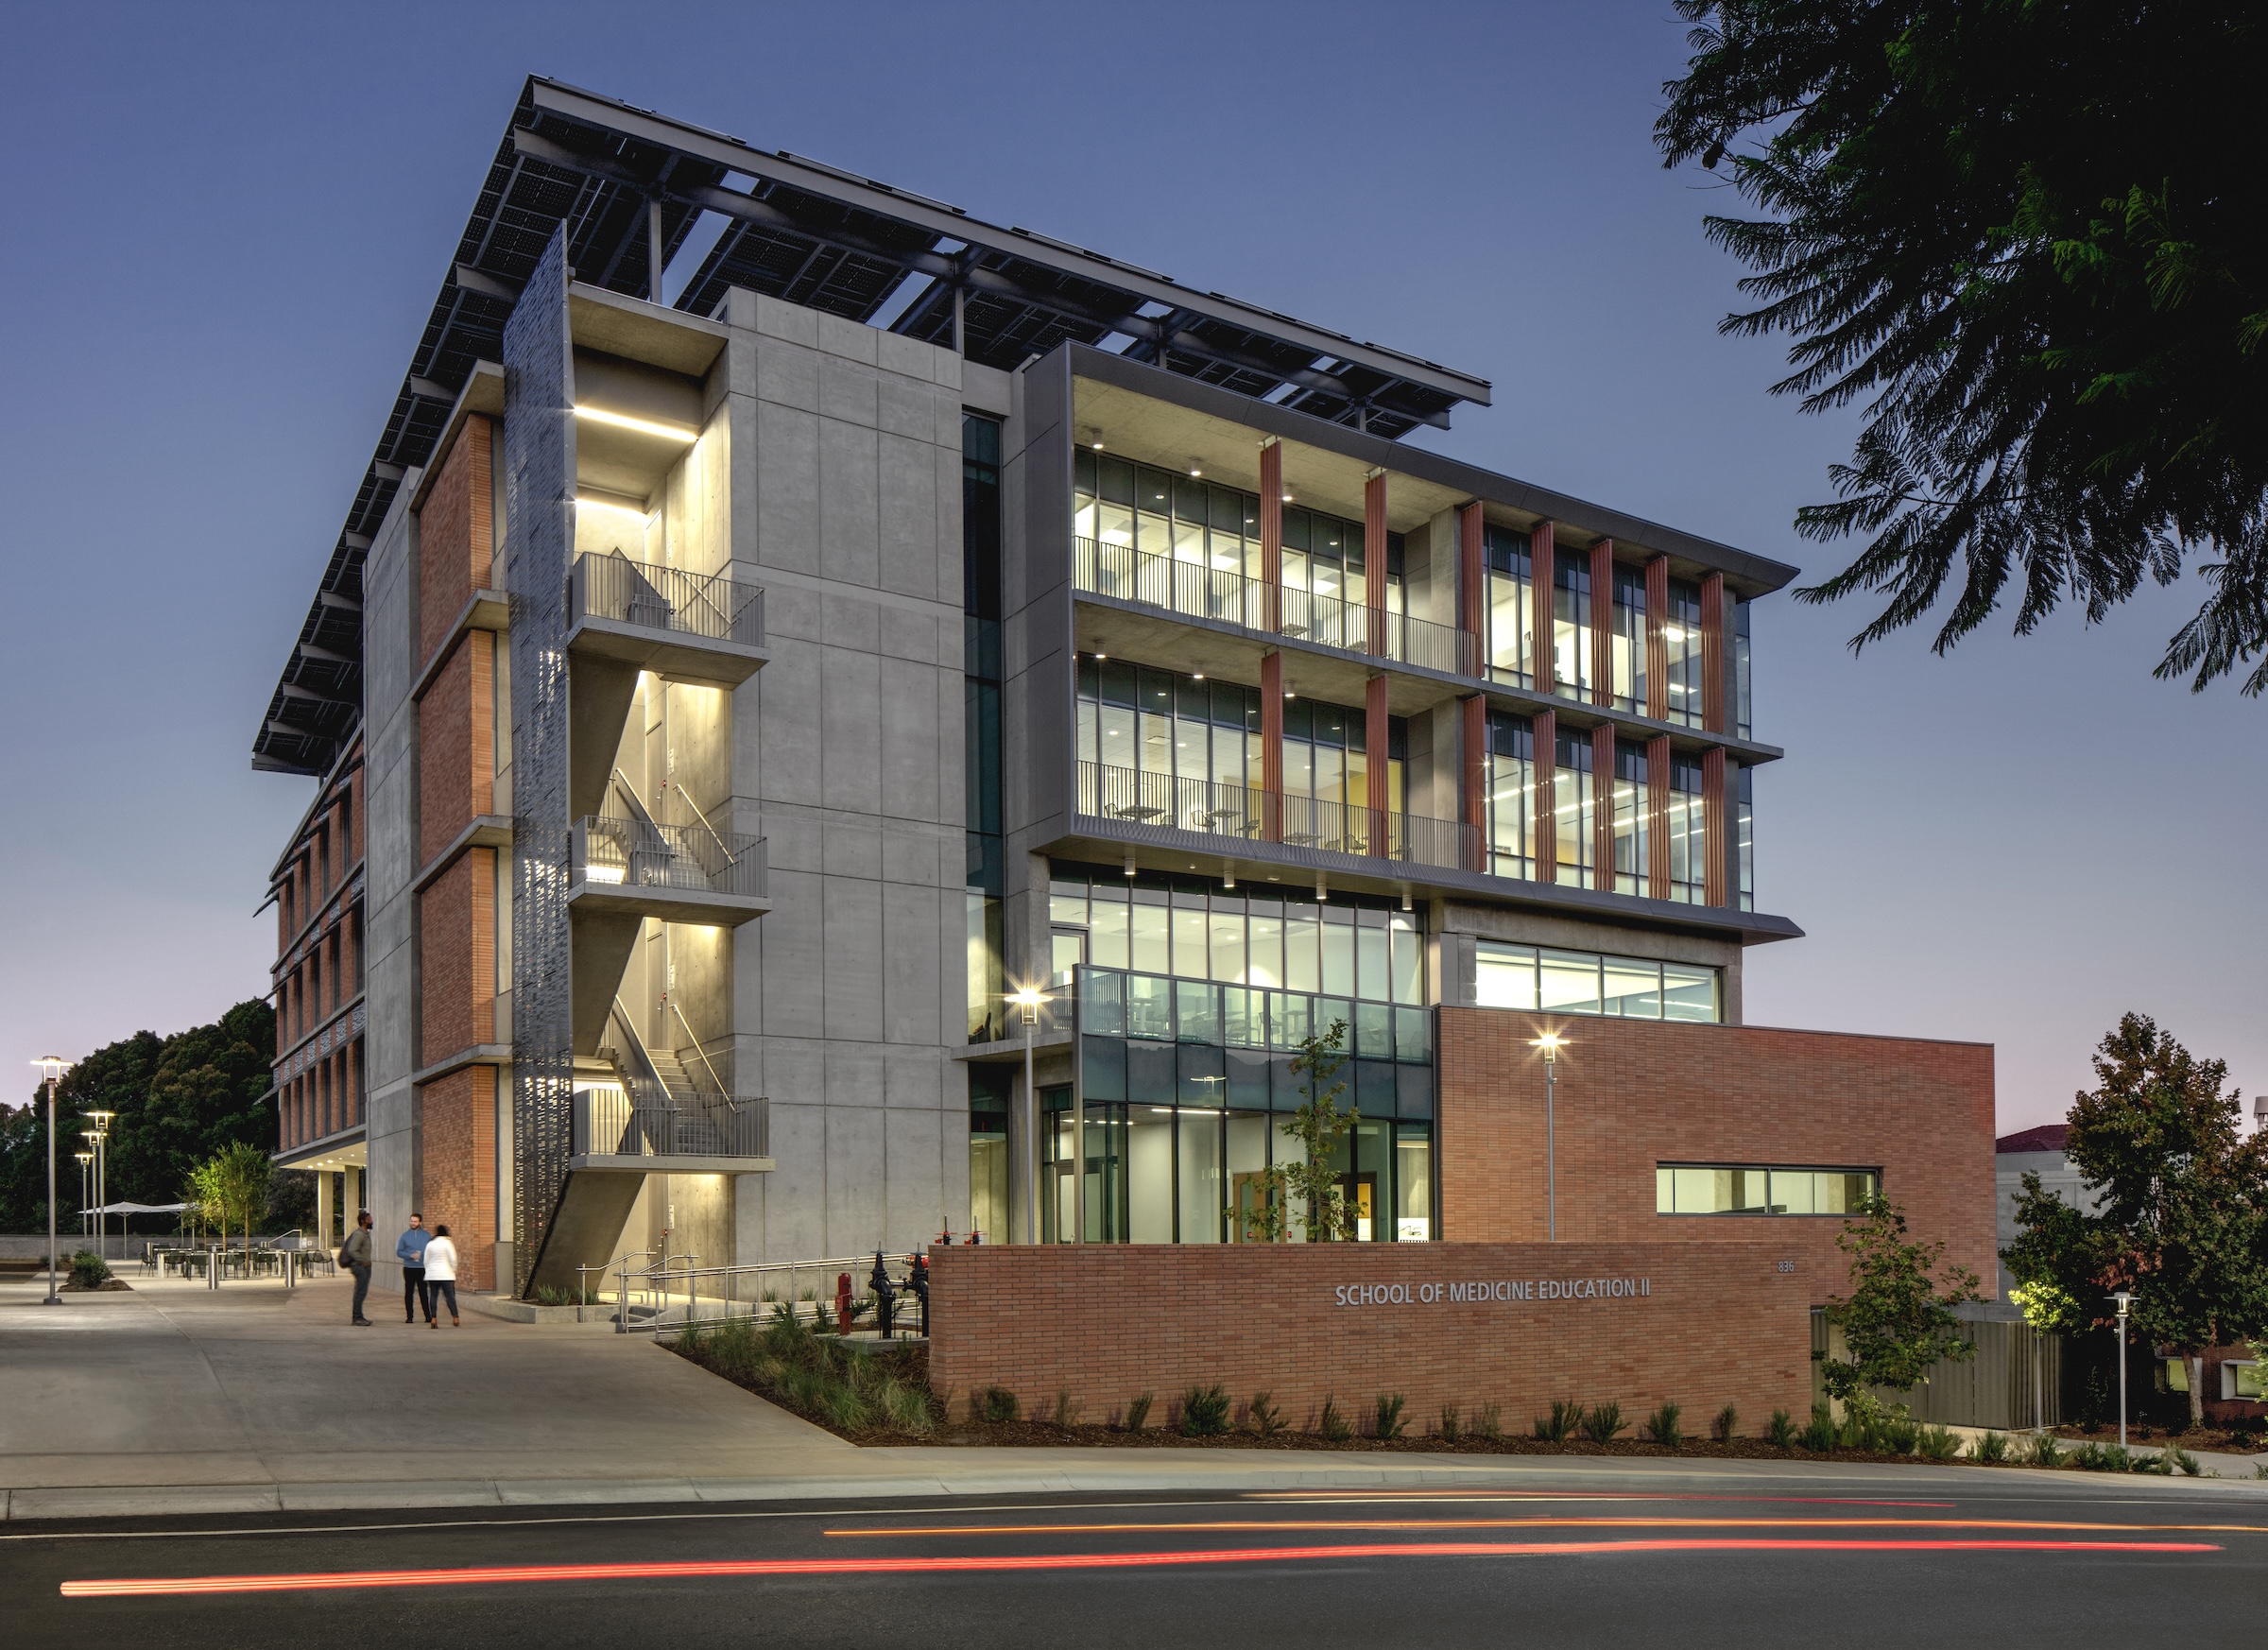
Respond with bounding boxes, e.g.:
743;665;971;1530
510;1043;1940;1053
0;0;2268;1131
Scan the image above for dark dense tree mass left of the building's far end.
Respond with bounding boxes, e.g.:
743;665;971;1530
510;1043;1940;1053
0;997;277;1230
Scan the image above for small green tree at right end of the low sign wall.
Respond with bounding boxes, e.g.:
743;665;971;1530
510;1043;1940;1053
1824;1195;1983;1403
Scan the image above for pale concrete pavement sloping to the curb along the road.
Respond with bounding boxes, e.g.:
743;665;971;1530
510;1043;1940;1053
0;1280;2268;1521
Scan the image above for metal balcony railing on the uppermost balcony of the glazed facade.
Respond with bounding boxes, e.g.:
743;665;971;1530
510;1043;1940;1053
1071;540;1479;676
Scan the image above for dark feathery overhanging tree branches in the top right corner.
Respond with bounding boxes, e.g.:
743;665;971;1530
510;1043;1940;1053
1656;0;2268;696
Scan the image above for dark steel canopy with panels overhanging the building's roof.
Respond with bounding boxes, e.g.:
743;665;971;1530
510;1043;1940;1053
251;77;1487;775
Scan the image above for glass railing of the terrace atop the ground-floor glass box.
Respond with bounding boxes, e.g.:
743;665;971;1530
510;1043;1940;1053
1079;966;1434;1065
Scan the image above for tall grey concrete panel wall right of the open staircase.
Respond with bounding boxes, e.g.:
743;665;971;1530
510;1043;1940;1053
721;292;969;1263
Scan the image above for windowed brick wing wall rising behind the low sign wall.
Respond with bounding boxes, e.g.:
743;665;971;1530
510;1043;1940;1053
1438;1008;1996;1301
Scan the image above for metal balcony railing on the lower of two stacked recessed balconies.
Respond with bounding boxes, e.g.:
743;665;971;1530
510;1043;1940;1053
1077;762;1481;870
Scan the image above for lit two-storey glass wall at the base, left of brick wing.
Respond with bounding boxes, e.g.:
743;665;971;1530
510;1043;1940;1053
1043;864;1434;1242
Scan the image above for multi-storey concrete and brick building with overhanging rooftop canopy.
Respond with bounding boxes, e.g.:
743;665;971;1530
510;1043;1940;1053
254;79;1991;1292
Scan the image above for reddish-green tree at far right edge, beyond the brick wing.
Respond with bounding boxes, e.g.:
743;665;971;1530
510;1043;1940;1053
2002;1013;2268;1423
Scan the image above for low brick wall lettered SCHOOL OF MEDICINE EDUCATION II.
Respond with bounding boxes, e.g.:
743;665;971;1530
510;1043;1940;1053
930;1232;1805;1435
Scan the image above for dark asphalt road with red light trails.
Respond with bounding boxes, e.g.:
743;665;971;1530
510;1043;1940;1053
0;1471;2268;1650
